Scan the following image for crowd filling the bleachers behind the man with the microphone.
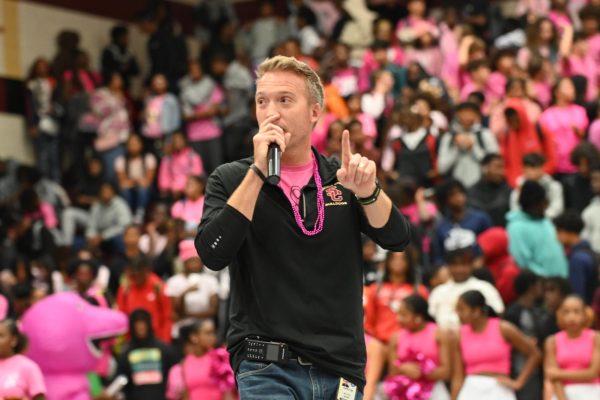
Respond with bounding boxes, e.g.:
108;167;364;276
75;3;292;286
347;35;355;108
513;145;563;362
0;0;600;400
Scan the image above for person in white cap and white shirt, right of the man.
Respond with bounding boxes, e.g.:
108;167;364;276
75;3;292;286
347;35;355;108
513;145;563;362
429;228;504;332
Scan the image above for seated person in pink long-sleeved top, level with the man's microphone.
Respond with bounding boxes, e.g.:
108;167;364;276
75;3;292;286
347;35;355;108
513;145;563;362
158;132;204;198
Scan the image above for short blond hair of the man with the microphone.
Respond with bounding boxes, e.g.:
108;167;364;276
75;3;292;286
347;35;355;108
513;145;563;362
256;56;325;108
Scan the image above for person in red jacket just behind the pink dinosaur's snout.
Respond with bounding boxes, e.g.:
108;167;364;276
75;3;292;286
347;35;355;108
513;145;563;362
117;256;173;343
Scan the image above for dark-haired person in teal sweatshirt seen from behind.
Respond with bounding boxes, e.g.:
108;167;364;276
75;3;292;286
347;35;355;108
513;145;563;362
507;181;569;278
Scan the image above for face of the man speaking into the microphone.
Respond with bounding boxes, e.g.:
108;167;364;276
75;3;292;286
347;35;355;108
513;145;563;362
256;71;321;149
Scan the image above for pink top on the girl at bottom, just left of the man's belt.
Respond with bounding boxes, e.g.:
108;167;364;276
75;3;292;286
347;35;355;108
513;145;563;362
167;354;223;400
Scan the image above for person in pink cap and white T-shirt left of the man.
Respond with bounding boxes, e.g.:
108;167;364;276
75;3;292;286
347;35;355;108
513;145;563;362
165;240;219;338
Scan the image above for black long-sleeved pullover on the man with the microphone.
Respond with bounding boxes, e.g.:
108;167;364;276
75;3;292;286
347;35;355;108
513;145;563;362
196;151;410;390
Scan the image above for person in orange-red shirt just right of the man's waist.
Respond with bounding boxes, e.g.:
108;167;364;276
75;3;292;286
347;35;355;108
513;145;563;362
364;248;429;343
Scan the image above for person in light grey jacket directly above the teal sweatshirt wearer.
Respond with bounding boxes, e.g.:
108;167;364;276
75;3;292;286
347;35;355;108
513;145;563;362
510;153;565;218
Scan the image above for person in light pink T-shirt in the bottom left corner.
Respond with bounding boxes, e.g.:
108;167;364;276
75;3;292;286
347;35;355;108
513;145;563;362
0;319;46;400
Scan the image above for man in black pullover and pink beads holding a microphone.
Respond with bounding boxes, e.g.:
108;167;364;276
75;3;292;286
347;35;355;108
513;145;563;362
196;56;410;400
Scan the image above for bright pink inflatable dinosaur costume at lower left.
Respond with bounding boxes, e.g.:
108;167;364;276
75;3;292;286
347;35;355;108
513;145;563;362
21;293;128;400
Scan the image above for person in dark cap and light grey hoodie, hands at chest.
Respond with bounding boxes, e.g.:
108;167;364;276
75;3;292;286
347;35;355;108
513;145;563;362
438;102;500;188
